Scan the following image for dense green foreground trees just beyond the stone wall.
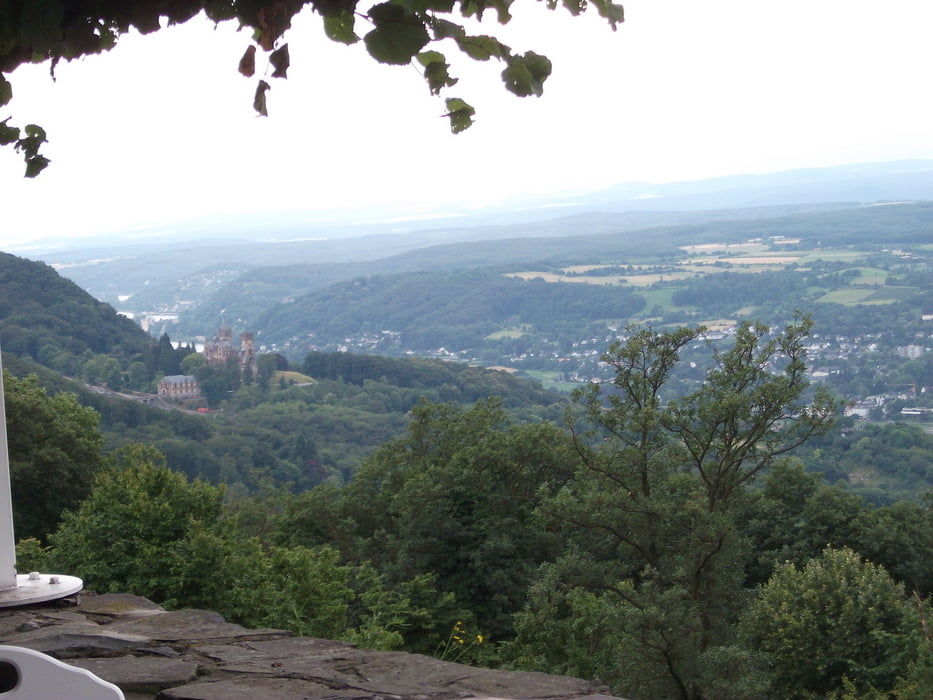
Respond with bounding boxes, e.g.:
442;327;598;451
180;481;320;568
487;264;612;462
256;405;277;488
7;318;933;699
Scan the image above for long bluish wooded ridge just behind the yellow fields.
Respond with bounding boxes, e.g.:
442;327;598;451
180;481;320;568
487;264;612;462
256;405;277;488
177;202;933;335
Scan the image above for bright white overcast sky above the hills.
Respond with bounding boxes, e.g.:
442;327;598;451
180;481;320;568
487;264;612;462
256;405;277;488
0;0;933;250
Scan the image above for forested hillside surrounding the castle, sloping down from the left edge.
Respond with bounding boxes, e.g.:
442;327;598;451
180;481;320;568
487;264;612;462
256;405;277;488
0;256;564;484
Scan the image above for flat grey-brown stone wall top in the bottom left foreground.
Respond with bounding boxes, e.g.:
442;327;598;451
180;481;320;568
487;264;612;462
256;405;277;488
0;593;614;700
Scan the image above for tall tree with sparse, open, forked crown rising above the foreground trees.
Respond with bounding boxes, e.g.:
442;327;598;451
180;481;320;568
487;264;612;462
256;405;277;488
517;318;838;700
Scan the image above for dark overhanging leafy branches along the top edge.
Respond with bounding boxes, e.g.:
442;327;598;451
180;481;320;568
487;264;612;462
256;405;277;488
0;0;624;177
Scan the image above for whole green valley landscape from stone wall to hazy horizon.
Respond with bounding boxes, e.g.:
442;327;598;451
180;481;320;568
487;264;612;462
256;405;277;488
0;161;933;698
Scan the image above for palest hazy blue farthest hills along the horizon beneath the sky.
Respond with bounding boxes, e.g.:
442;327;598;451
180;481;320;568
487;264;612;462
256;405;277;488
32;160;933;326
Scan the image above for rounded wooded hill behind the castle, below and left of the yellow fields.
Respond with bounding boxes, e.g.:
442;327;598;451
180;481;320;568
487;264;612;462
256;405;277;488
257;269;645;351
